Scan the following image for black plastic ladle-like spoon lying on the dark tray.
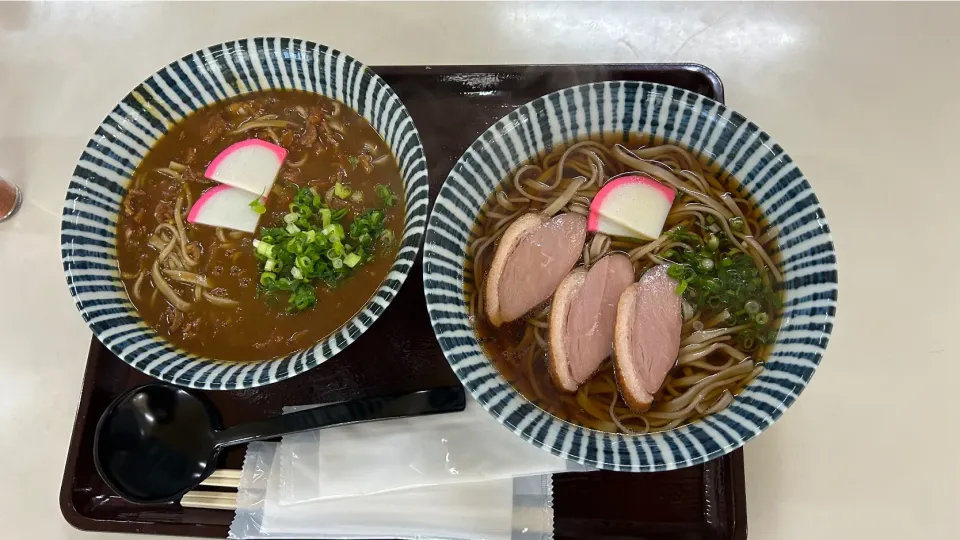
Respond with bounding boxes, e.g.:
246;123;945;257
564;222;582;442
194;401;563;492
93;384;466;504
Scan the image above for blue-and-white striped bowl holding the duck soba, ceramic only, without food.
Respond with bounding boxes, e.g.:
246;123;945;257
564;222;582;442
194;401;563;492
423;82;837;471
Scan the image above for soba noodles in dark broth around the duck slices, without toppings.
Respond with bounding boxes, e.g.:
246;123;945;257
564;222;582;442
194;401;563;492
467;136;782;433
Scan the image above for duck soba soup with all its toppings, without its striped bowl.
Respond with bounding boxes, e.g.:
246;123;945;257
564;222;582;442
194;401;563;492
466;134;782;433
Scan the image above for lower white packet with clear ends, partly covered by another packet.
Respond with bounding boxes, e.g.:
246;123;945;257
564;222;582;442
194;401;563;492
228;443;553;540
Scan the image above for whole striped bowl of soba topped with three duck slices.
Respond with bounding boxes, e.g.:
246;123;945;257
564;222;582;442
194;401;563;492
424;82;837;471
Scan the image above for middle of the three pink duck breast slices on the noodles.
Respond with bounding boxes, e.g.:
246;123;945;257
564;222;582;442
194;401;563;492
549;253;633;392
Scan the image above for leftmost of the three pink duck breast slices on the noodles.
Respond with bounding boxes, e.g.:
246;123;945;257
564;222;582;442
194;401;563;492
485;213;587;326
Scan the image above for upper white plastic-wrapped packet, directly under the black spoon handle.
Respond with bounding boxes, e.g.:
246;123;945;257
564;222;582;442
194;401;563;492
279;400;589;505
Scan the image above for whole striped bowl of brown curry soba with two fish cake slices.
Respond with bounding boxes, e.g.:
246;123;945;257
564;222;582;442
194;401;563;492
61;38;428;389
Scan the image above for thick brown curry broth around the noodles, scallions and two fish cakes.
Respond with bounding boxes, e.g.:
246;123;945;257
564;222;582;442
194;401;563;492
117;91;404;361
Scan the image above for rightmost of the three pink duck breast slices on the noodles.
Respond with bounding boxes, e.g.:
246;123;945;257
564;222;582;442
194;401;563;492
613;265;683;412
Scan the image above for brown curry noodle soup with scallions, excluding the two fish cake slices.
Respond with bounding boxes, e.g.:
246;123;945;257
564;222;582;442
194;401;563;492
117;90;404;361
